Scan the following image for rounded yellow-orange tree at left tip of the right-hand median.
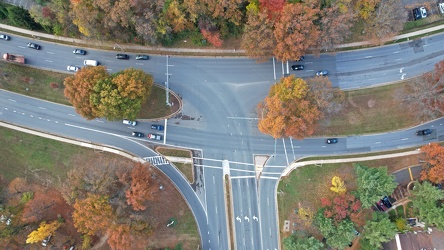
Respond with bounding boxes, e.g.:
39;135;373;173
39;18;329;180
258;75;322;139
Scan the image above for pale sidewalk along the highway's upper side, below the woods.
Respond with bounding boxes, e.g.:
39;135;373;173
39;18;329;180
0;24;444;55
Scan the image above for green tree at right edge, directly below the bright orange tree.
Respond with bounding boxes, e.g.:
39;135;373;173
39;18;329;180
410;181;444;230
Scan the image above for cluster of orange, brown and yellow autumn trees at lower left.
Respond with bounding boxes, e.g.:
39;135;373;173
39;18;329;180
0;158;177;249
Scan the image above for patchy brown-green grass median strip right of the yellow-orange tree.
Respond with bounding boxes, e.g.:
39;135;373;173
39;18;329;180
314;80;421;136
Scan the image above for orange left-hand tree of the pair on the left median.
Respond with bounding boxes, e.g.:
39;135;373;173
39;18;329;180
63;66;109;120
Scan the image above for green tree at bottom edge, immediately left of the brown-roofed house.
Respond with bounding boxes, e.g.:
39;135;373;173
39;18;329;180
363;212;397;249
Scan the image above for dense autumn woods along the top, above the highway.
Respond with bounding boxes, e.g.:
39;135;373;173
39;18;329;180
0;0;407;60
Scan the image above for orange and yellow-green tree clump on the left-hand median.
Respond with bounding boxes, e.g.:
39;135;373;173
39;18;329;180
64;66;153;120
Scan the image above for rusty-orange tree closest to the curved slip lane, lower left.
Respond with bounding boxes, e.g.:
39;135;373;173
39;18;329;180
126;163;157;211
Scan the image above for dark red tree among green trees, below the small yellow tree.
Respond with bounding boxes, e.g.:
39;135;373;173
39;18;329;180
321;194;361;223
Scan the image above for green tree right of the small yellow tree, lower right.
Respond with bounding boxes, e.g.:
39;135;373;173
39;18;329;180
355;164;397;208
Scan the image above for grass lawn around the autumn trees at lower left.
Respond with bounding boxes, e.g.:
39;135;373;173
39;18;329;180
0;127;200;249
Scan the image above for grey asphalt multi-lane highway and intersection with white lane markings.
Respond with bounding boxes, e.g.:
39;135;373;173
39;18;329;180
0;30;444;249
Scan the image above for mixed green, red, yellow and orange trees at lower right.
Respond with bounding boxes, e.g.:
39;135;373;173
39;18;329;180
282;143;444;250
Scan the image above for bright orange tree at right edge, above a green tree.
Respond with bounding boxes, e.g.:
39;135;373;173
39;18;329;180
421;143;444;183
